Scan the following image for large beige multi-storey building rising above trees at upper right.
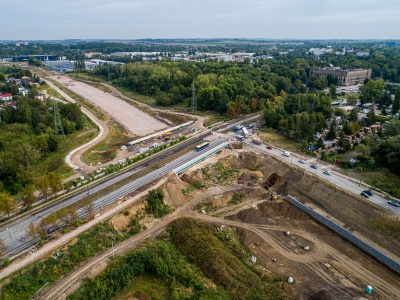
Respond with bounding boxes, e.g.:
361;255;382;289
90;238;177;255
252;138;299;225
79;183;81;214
311;67;371;85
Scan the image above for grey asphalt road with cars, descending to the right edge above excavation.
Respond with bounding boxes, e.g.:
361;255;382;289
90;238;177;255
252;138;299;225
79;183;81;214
245;138;400;215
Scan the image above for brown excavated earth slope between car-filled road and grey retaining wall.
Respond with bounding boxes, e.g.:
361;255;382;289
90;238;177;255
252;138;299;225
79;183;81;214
219;151;400;257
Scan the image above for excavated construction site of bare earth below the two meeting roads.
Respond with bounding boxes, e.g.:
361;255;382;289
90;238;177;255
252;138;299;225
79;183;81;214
37;144;400;299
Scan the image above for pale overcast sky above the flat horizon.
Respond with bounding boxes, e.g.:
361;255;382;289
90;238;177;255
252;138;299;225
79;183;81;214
0;0;400;40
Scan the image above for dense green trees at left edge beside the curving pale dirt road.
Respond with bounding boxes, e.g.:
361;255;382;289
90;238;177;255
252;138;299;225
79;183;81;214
0;72;87;195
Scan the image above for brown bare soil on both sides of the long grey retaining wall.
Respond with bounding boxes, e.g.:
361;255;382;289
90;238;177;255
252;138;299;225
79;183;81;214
181;150;400;300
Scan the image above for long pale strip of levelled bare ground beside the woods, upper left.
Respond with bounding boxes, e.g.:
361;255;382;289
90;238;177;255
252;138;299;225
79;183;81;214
52;76;166;135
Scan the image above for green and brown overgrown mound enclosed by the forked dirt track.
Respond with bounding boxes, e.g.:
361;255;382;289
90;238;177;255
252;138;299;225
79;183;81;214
69;218;289;300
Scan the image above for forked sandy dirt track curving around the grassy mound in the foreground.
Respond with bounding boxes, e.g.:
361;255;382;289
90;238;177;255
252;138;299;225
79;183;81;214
41;197;400;300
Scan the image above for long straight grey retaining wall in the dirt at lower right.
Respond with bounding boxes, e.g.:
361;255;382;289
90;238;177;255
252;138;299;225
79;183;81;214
285;196;400;274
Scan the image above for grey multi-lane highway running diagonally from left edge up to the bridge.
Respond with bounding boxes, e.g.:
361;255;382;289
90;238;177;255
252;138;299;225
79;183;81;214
0;139;225;255
